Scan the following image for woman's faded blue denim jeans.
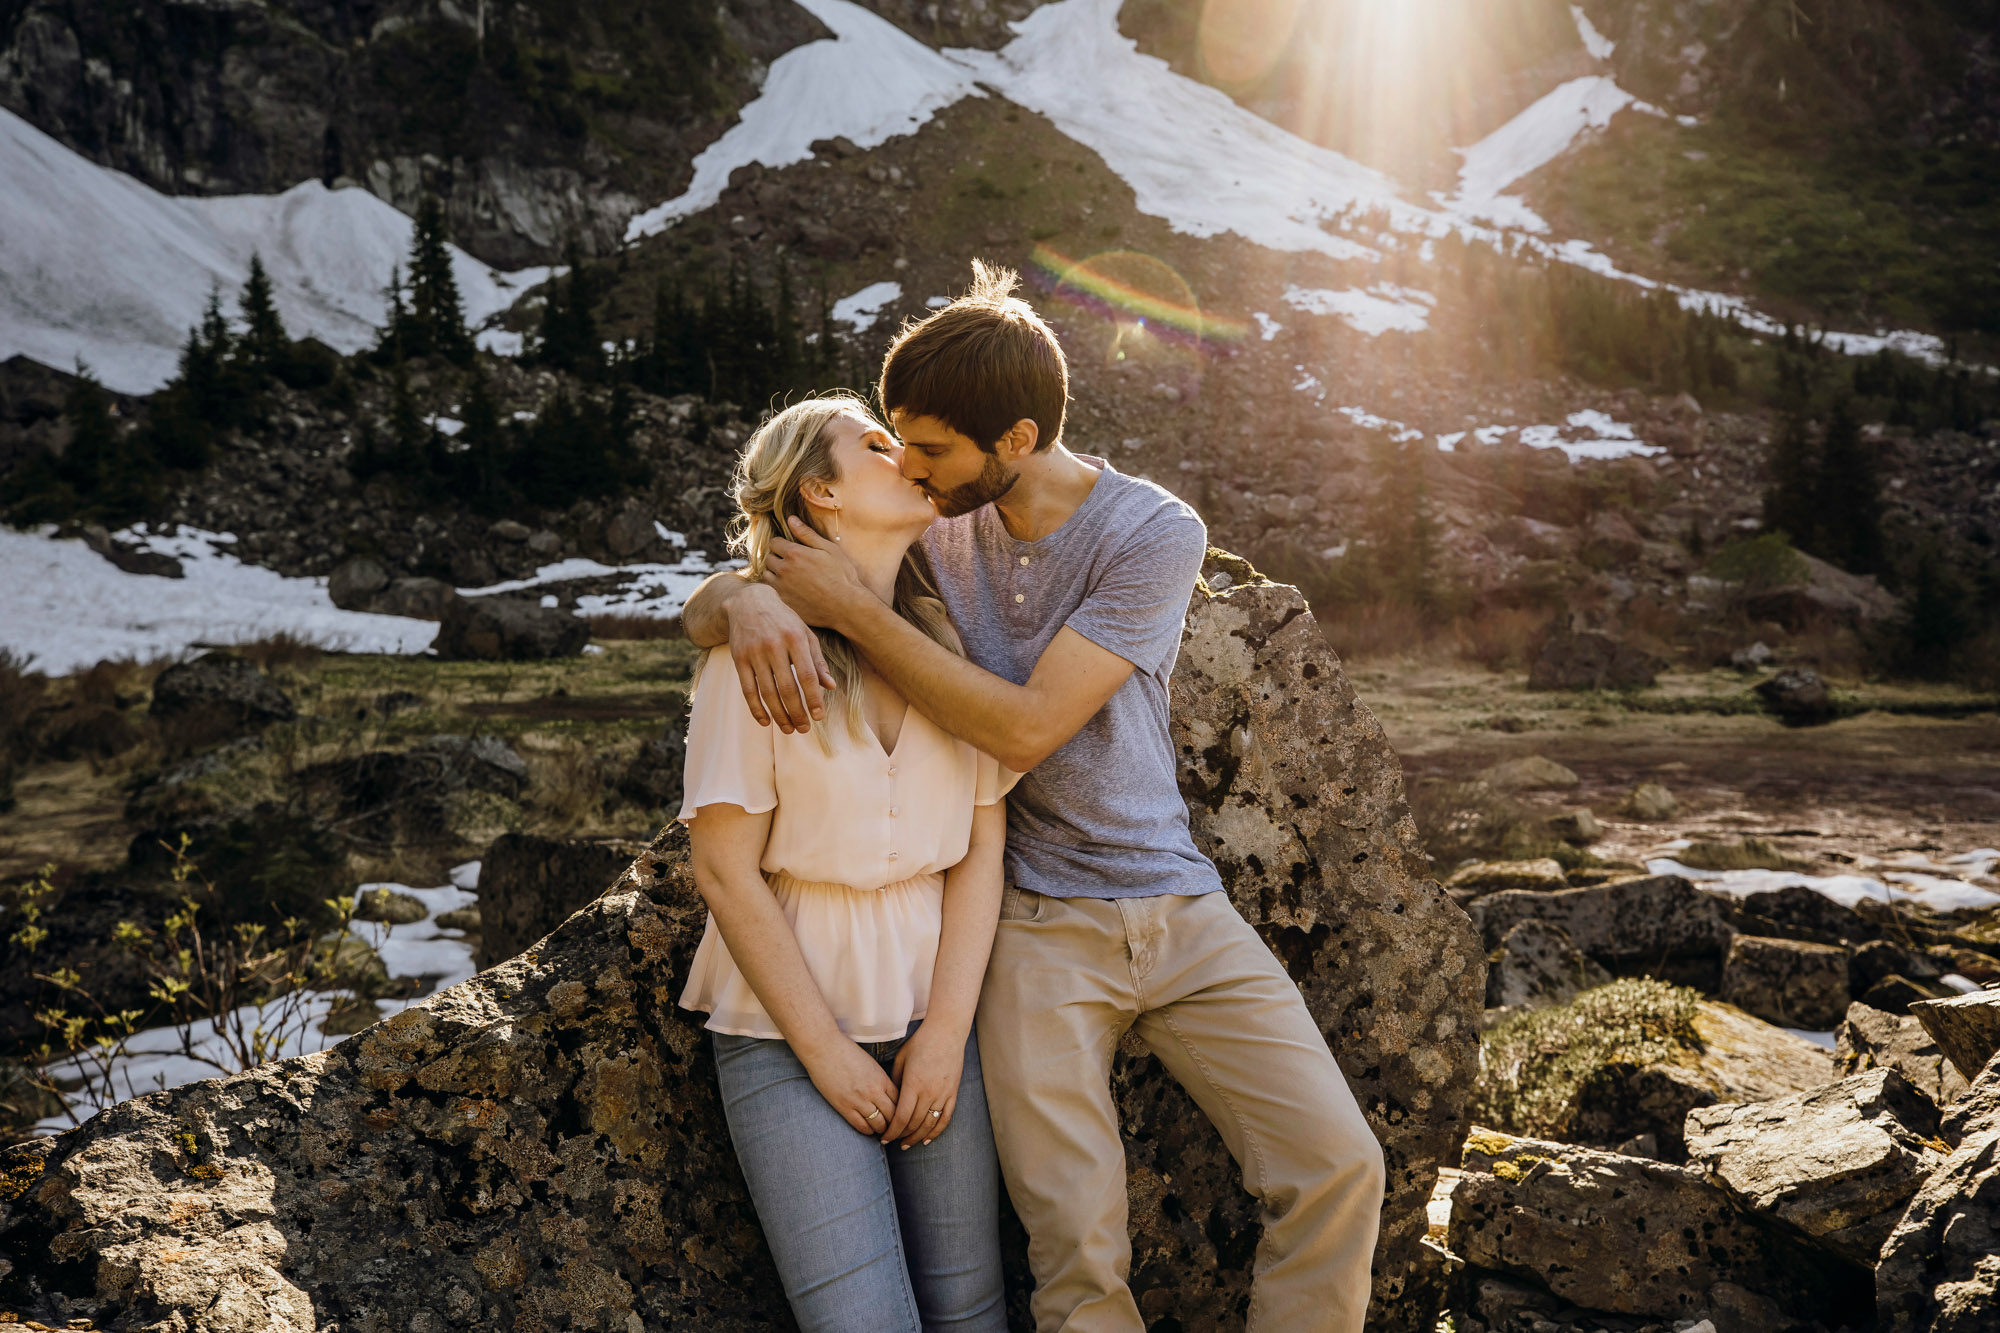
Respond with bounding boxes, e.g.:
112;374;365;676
712;1023;1006;1333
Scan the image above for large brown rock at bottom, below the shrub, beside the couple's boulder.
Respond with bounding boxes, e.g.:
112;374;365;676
1450;1129;1868;1319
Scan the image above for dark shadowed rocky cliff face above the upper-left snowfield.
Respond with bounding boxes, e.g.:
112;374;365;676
0;0;826;266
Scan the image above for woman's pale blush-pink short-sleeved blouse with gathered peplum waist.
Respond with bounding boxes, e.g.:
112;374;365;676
678;648;1020;1041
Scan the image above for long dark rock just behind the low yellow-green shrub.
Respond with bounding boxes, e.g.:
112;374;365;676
1466;875;1732;965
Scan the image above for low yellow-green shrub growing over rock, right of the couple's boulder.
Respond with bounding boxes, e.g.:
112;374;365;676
1468;979;1702;1139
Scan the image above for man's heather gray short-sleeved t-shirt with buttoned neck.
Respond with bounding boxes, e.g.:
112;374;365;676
924;458;1222;899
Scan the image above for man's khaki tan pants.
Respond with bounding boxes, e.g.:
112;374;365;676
978;889;1384;1333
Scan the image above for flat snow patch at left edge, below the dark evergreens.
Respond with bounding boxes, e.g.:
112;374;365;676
0;526;438;675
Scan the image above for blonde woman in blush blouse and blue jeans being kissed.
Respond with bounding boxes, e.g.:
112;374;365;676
680;396;1016;1333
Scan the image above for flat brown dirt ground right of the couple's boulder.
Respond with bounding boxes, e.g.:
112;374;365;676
1348;662;2000;871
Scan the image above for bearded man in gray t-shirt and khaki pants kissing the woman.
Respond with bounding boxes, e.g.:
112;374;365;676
684;264;1384;1333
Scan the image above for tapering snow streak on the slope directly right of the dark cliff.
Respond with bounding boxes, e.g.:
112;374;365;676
626;0;982;240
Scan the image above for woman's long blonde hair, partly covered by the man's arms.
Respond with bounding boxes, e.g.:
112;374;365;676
728;392;964;755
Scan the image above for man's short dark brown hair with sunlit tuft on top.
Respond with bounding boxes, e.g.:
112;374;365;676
880;260;1070;452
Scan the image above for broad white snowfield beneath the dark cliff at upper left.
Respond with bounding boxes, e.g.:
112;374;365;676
0;110;548;394
